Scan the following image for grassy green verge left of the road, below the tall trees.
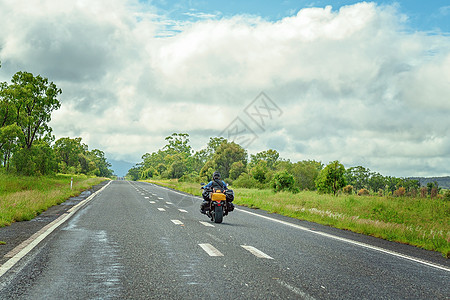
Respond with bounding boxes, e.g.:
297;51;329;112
0;173;106;227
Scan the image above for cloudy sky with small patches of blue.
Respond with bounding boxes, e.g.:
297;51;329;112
0;0;450;177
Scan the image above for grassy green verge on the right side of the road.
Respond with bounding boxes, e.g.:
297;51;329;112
151;180;450;258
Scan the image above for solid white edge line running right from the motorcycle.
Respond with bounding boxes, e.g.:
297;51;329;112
235;209;450;272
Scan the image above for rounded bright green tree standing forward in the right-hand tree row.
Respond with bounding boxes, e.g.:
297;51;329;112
316;160;346;196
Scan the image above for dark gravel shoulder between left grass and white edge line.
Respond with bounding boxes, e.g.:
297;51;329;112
0;181;108;265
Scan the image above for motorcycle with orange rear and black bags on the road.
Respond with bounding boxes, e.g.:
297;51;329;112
201;183;234;223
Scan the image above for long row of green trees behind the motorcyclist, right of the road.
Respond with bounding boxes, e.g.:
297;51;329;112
127;133;439;196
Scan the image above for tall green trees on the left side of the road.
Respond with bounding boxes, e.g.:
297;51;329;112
0;65;113;177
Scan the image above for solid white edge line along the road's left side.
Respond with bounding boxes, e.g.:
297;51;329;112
0;180;112;277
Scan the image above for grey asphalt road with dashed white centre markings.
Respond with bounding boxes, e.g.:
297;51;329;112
0;181;450;299
